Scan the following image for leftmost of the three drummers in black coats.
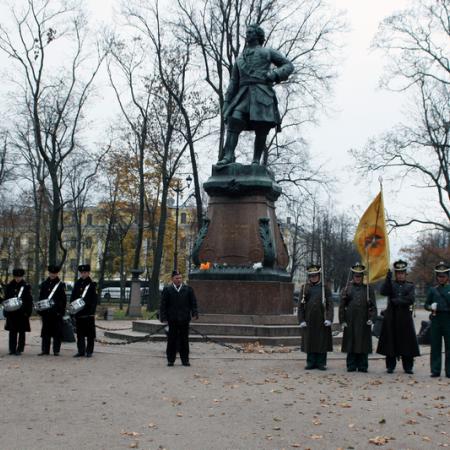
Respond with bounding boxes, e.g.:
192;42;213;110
4;269;33;355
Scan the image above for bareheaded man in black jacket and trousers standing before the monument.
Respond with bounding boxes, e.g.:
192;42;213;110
159;270;198;366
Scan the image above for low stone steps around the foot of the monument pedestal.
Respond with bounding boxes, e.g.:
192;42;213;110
105;314;341;346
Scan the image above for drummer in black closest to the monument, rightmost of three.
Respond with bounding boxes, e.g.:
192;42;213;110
70;264;98;358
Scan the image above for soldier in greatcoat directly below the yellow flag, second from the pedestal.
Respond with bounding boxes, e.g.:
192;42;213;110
339;263;377;372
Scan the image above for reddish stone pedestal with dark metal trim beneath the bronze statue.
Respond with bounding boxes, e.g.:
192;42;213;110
189;163;294;315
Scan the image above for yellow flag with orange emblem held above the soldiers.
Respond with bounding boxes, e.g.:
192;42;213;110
353;191;389;283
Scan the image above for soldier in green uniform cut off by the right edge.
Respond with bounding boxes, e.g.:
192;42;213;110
425;262;450;378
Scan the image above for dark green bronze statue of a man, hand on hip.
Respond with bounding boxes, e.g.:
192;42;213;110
217;25;294;165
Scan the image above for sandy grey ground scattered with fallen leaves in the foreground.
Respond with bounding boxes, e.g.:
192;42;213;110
0;321;450;450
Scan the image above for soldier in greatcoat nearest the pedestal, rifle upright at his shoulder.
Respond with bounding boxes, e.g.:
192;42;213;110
298;264;334;370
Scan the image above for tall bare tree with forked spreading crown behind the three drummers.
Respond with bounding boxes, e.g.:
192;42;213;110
0;0;109;264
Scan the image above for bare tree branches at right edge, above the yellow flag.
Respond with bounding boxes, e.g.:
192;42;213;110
353;0;450;232
